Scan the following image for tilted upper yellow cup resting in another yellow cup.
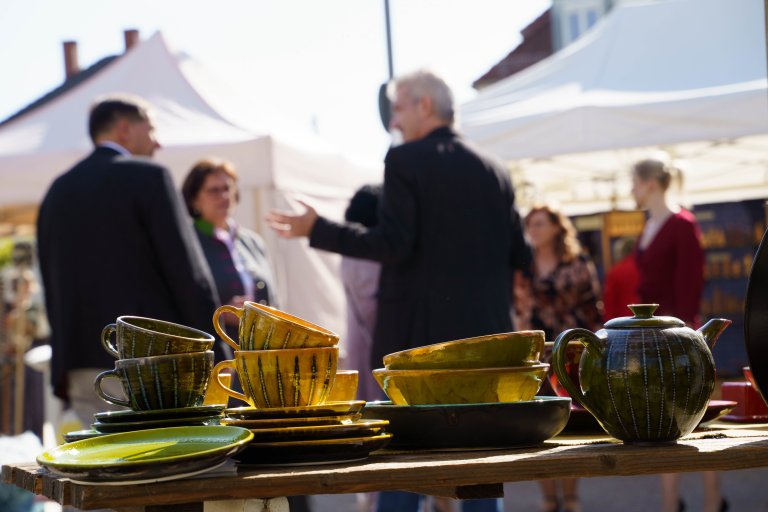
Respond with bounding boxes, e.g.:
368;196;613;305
213;302;339;350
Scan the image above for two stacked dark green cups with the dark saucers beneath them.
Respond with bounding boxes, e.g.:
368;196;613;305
66;316;225;441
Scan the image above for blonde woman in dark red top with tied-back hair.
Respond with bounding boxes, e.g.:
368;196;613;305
632;158;728;512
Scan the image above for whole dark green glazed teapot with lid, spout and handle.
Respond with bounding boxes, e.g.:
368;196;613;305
552;304;731;443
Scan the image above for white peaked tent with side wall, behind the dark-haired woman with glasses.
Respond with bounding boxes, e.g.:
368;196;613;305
0;33;382;335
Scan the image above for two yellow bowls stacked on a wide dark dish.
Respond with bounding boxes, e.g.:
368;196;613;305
364;331;571;448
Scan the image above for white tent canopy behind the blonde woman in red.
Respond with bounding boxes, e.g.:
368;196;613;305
461;0;768;214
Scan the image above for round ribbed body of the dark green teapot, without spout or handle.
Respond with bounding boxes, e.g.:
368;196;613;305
580;327;715;442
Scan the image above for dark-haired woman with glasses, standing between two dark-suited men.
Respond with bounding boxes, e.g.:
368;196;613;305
181;158;276;348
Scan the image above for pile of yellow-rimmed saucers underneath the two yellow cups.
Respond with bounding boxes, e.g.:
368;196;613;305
221;400;392;466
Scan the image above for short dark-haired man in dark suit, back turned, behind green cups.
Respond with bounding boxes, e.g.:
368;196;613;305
37;97;218;425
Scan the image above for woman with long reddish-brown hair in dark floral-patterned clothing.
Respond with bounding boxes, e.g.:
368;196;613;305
515;205;602;512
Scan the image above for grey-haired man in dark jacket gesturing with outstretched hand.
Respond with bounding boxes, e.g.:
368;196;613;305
269;71;529;512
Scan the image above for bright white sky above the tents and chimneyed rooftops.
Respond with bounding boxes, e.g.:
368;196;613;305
0;0;551;161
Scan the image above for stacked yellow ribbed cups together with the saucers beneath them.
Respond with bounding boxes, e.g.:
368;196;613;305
212;302;391;465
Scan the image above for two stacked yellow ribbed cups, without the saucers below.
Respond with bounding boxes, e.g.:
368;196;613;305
211;302;339;409
